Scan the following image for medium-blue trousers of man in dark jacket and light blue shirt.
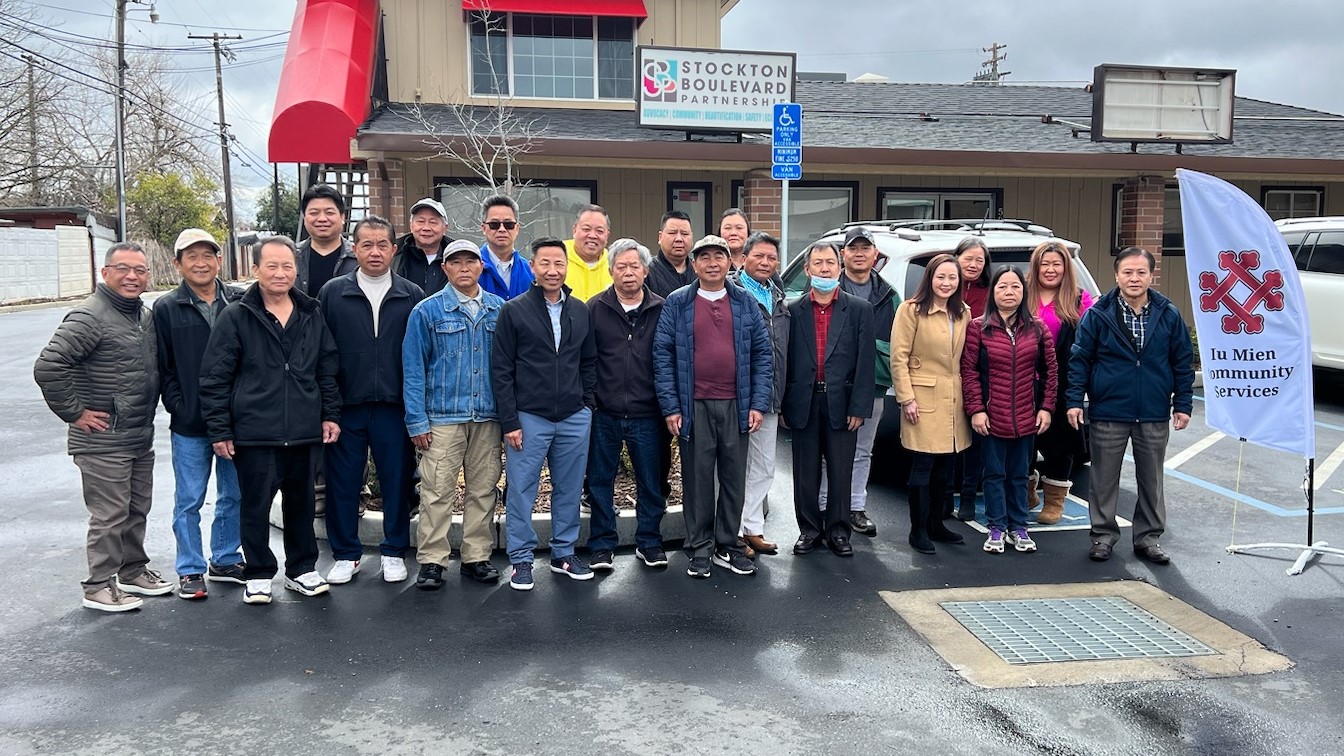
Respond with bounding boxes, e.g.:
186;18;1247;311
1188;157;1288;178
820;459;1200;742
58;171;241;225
504;408;593;564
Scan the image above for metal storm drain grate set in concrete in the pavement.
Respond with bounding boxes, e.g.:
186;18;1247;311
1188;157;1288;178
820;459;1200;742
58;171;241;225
938;596;1218;665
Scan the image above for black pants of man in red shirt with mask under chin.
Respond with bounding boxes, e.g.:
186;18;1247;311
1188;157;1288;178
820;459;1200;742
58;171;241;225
793;394;859;538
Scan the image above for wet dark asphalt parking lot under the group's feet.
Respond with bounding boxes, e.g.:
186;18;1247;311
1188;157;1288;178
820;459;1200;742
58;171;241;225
0;302;1344;755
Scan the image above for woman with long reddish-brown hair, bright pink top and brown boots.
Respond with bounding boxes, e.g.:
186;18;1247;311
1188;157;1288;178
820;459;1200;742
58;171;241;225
1027;241;1093;525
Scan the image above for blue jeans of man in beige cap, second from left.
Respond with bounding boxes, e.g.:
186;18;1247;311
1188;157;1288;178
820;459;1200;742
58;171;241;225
172;433;243;574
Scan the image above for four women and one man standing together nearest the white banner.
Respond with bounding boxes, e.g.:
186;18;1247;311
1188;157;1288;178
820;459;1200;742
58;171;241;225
891;237;1195;564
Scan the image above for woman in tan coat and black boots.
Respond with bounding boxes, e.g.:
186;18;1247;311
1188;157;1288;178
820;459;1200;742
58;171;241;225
891;254;970;554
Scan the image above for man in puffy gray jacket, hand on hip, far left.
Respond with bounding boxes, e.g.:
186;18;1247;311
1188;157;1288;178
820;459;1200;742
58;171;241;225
32;242;173;612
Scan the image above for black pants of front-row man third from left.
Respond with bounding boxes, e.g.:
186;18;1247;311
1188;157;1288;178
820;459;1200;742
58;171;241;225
234;444;321;580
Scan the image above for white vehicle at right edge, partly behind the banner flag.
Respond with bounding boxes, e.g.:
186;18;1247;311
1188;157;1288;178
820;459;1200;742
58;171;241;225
1275;217;1344;370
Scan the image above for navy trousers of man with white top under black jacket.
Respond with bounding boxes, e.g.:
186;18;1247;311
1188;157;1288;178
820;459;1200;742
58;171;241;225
324;402;415;561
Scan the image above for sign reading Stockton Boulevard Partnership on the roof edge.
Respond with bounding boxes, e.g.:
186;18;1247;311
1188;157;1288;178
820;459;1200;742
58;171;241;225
636;47;797;132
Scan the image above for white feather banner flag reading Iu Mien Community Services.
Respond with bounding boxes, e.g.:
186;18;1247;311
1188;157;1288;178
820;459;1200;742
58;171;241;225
1176;168;1316;459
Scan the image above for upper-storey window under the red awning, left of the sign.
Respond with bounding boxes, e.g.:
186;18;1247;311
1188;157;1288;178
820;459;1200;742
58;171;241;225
470;12;636;100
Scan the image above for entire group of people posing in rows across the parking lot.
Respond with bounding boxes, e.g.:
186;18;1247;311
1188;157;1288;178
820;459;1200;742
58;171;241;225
35;184;1189;612
